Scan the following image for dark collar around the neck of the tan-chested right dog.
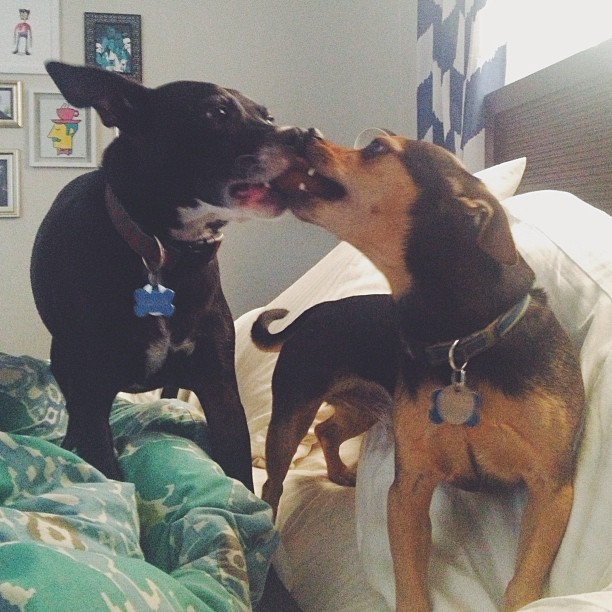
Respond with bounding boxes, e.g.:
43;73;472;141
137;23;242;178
407;293;531;369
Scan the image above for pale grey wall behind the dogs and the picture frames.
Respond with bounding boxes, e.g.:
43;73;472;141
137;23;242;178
0;0;417;357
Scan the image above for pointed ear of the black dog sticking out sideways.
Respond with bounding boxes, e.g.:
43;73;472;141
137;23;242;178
45;62;149;132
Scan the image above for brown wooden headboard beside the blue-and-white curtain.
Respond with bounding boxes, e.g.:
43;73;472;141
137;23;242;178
485;40;612;214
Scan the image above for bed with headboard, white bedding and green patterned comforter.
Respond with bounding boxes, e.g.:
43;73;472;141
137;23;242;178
0;41;612;612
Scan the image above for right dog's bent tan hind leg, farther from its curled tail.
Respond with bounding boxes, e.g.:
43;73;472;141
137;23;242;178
315;378;392;487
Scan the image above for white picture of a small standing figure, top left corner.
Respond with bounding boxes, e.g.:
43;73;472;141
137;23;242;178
0;0;60;74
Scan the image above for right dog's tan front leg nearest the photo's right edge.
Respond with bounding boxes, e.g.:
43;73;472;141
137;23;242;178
504;480;574;610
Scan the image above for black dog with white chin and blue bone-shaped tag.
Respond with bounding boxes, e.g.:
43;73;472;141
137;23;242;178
31;62;302;489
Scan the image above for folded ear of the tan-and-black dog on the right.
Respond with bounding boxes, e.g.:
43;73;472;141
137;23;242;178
457;196;518;266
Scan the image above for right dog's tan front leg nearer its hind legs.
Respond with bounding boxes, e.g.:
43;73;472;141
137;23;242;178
387;462;436;612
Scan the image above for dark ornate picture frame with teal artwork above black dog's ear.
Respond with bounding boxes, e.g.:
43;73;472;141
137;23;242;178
85;13;142;83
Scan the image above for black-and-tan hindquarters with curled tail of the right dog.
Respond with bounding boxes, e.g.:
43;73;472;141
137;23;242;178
251;294;400;512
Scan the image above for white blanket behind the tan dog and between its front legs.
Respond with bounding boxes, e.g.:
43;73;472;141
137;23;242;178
357;191;612;612
